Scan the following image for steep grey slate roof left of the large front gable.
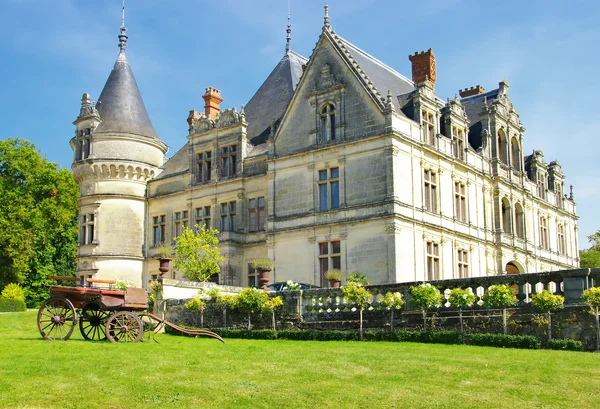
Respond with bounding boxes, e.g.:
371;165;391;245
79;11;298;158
244;50;308;145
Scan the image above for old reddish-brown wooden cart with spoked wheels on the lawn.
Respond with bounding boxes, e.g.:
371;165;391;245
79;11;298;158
37;276;224;342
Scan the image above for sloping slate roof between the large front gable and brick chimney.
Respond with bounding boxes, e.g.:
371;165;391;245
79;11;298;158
336;34;416;115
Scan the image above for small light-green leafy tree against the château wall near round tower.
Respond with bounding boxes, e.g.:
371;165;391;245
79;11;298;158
174;225;225;281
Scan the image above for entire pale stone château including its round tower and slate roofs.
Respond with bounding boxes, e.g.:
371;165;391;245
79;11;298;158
71;7;579;286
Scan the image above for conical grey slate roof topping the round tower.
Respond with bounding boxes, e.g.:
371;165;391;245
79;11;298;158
96;25;158;139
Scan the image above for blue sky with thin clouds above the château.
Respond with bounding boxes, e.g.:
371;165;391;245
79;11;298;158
0;0;600;248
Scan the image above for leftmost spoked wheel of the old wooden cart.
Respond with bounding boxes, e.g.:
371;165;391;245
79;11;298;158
38;297;77;341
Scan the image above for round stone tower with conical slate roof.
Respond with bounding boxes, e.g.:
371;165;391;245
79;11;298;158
70;19;167;287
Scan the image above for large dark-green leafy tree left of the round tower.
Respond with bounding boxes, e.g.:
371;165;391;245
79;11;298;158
0;139;79;306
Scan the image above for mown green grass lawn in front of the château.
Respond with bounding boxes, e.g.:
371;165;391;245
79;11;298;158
0;312;600;409
